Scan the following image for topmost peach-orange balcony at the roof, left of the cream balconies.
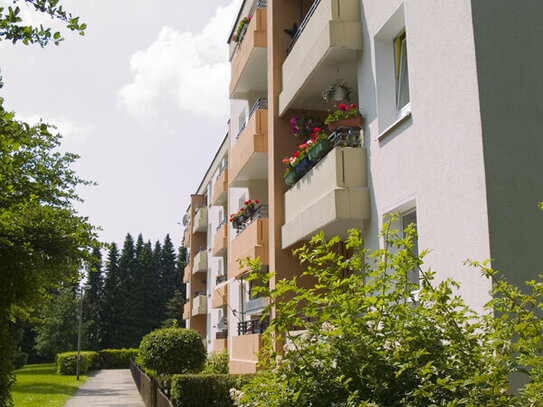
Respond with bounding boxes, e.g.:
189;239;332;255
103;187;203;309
230;1;268;99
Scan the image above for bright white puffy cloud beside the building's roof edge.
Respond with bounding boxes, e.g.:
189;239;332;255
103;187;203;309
118;0;239;120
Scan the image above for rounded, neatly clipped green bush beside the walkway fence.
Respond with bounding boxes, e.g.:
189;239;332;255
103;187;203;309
138;328;206;374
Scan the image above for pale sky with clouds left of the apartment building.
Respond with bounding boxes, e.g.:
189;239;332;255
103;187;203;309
0;0;241;246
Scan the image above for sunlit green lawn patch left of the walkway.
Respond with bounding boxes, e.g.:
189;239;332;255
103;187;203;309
11;363;87;407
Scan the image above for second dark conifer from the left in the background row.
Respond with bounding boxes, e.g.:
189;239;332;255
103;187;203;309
100;243;122;348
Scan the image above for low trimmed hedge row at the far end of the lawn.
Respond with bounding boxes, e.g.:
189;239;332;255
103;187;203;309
56;349;138;375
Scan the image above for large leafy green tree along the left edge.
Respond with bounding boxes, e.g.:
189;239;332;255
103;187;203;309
0;104;98;405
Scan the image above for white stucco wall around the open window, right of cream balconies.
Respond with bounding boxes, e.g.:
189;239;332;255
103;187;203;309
358;0;490;310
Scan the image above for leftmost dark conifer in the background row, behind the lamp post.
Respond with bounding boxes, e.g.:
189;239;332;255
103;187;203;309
83;247;103;350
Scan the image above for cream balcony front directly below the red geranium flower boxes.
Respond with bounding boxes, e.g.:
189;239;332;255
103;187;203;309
281;127;370;249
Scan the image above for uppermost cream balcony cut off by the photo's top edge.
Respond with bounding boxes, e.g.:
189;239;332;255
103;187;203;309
279;0;363;116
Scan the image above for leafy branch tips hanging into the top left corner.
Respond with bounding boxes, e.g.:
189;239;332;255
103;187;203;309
0;0;87;47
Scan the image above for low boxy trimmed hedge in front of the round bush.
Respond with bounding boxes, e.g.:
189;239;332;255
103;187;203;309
171;374;252;407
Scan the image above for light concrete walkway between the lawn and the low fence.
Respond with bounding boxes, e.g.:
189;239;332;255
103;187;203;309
64;369;144;407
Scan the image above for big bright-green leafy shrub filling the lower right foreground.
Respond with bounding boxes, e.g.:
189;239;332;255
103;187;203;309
236;223;543;407
